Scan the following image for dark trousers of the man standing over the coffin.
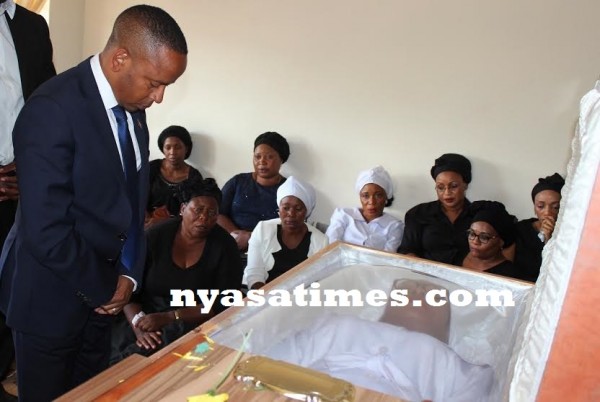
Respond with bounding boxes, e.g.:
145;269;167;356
13;310;114;402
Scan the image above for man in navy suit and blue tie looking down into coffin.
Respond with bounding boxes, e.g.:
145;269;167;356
0;5;187;402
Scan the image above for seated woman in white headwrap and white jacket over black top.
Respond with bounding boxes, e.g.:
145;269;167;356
242;176;328;289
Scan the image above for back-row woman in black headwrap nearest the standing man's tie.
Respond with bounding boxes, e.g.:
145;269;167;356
146;126;202;227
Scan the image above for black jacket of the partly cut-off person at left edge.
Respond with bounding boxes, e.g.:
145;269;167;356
4;4;56;100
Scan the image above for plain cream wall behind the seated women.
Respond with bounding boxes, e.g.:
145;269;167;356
51;0;600;225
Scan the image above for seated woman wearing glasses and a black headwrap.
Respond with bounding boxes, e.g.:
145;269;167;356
462;201;520;279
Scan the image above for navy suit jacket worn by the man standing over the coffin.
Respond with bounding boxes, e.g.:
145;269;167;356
0;59;149;337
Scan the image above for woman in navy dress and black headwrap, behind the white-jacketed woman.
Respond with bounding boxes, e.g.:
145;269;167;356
218;132;290;251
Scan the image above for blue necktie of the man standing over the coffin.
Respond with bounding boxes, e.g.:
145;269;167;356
112;105;141;271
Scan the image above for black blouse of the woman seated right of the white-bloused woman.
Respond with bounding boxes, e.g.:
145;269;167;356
398;199;473;265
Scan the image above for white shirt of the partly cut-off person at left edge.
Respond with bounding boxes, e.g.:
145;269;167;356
0;0;25;166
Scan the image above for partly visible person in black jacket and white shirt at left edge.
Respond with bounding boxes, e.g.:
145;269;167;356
0;0;56;401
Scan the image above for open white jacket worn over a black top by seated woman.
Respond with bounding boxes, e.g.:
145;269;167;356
242;218;329;288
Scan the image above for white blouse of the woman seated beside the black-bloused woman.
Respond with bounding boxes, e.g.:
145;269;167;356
326;208;404;253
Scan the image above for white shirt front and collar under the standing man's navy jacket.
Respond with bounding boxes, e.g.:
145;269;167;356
90;54;142;170
